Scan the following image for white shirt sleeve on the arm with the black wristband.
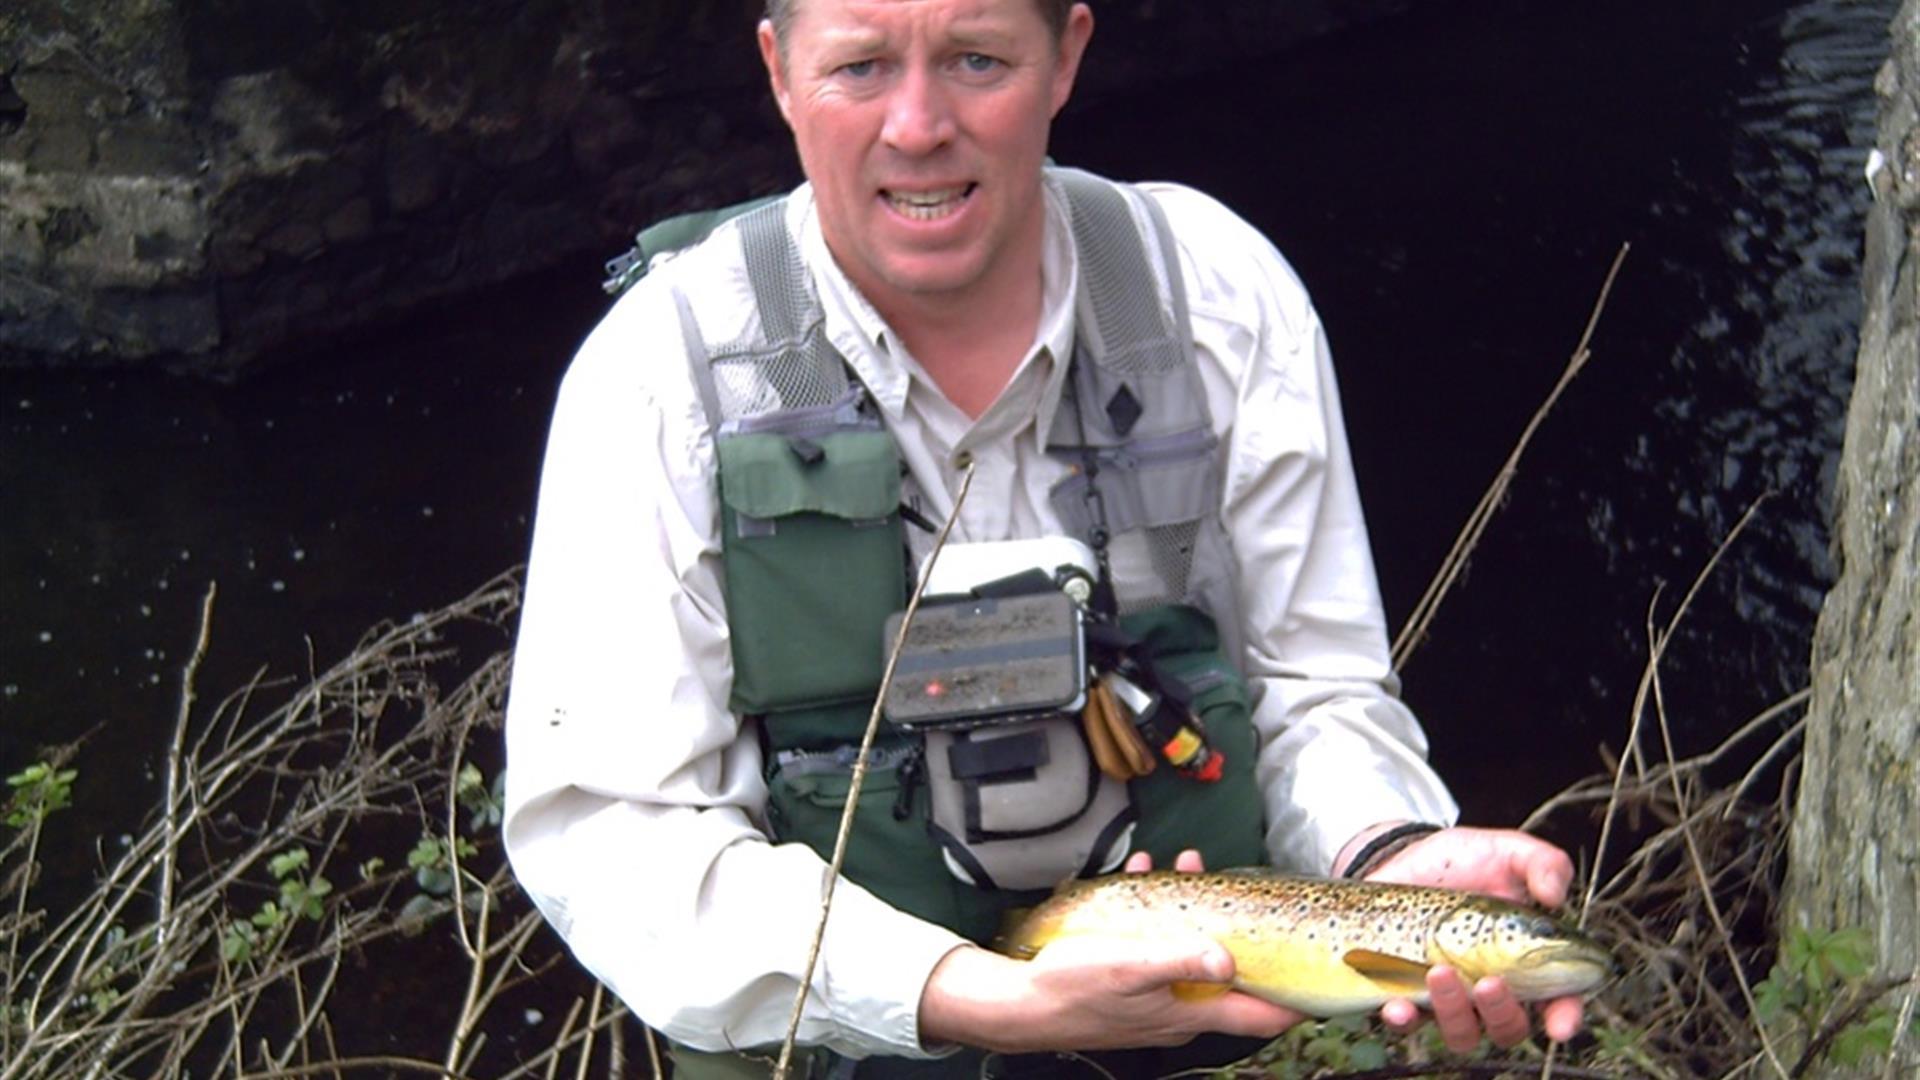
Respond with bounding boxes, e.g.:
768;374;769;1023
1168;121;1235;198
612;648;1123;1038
1150;186;1459;874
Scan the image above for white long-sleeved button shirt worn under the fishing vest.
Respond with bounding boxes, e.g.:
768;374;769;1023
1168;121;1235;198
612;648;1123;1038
505;171;1457;1057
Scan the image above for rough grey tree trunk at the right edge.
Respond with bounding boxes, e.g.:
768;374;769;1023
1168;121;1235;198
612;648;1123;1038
1786;0;1920;1076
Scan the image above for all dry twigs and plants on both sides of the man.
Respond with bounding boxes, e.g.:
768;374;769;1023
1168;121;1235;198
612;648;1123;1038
0;564;1847;1080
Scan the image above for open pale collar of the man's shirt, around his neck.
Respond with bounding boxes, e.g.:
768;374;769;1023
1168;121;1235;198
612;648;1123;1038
787;175;1079;430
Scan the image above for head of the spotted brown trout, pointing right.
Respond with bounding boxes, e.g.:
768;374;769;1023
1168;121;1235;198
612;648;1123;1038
1432;897;1617;1001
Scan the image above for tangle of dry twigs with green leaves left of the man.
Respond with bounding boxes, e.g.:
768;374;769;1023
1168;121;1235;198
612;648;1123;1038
0;578;643;1080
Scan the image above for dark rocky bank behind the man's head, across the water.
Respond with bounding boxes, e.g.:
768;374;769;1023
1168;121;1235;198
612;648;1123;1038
0;0;1411;373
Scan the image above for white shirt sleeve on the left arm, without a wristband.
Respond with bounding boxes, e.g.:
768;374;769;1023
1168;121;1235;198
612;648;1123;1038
505;279;962;1057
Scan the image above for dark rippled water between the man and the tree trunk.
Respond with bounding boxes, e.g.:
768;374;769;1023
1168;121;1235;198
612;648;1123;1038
1066;2;1895;821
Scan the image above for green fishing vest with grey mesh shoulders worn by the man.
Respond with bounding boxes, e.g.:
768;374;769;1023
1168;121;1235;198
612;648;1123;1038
637;167;1265;1068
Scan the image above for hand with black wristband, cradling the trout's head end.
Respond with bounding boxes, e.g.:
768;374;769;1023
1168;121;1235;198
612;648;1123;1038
1367;828;1582;1053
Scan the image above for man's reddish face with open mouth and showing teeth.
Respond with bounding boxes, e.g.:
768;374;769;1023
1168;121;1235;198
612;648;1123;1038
760;0;1092;311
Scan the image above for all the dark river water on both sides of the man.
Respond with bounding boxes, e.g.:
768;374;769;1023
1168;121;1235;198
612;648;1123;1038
0;0;1895;830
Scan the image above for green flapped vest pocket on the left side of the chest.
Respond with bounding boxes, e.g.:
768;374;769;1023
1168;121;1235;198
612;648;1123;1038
716;430;906;715
